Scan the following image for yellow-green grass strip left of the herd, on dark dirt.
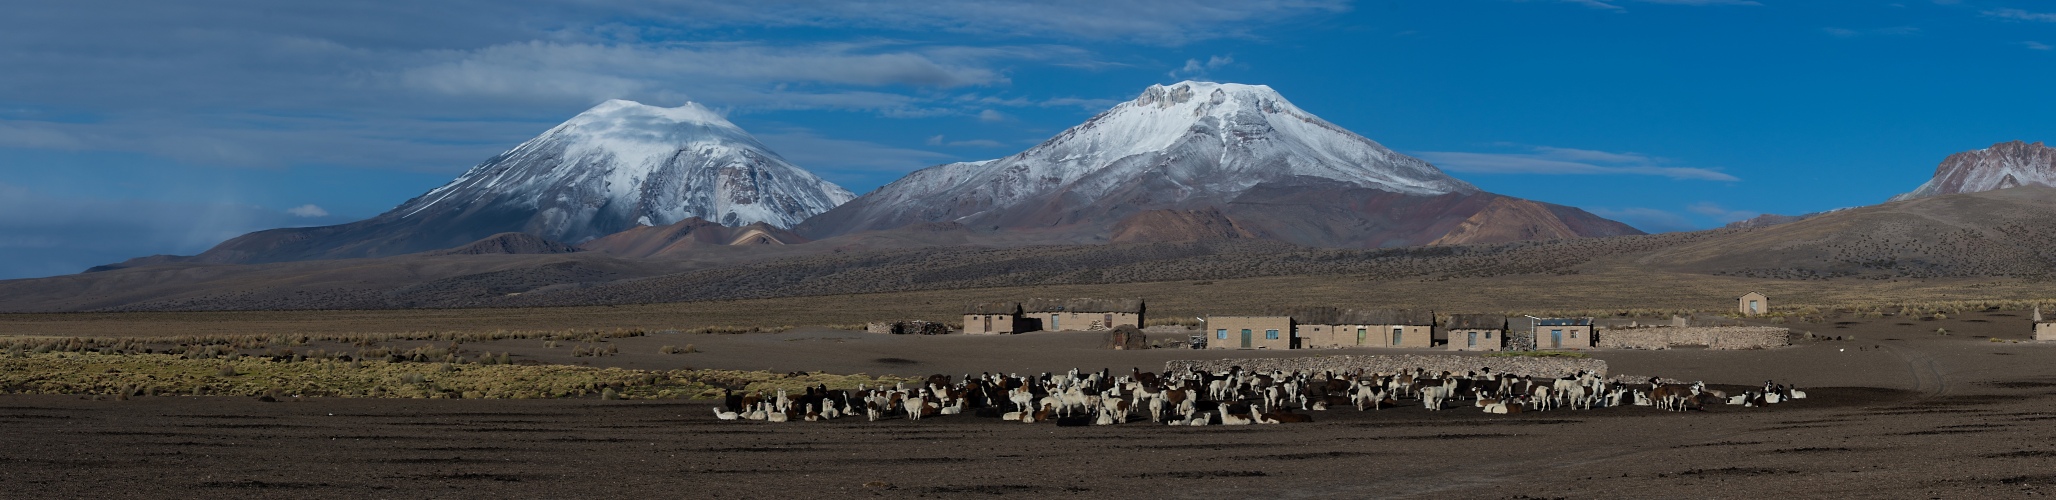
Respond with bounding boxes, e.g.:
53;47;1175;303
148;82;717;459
0;352;903;399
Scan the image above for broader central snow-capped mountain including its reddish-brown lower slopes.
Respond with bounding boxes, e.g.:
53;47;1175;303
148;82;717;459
796;82;1641;247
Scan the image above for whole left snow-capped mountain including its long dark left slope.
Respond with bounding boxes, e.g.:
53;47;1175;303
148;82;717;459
180;101;853;263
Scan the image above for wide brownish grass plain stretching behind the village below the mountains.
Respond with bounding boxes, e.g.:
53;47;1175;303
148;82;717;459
0;265;2056;337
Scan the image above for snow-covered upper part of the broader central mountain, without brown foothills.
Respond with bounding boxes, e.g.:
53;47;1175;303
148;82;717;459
810;82;1478;235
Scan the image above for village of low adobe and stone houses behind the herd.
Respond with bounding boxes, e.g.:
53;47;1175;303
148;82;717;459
868;292;1907;352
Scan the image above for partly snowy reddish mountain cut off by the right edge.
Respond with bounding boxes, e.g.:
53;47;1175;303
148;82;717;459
1892;140;2056;202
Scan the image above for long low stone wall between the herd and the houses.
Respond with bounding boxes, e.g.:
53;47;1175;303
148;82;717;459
1164;354;1606;377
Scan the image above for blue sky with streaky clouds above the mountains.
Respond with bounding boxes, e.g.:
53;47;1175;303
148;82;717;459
0;0;2056;278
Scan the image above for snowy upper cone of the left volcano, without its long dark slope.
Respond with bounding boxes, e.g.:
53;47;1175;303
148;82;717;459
405;99;855;236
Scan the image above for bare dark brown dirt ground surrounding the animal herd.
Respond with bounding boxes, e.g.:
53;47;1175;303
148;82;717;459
0;313;2056;498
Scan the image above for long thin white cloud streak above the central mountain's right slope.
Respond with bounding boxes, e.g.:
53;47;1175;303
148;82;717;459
1415;146;1741;181
